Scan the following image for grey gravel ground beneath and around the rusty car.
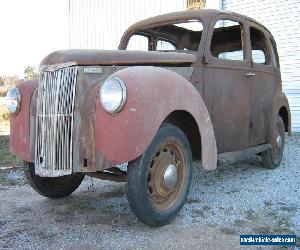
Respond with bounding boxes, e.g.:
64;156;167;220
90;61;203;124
0;136;300;249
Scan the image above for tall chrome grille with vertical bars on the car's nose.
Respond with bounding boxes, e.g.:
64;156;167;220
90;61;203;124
35;67;77;177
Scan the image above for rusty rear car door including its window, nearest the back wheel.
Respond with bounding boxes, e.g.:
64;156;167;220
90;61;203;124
249;22;280;146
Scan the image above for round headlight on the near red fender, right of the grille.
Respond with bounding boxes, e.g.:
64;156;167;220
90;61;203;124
100;77;127;114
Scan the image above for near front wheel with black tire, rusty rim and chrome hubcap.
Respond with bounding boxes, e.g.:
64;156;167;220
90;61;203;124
127;124;192;227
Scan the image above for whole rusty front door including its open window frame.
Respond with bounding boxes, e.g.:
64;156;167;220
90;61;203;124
204;14;251;153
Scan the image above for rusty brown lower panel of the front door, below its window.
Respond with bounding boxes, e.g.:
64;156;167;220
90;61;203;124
204;65;251;153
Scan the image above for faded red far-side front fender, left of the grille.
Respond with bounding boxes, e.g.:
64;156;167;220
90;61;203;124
10;80;38;162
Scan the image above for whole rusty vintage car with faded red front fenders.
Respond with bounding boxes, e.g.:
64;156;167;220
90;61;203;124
7;10;291;226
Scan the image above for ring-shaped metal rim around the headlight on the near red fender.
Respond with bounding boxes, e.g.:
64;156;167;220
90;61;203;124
99;76;127;115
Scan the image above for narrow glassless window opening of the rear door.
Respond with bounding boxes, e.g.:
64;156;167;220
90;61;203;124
250;27;269;64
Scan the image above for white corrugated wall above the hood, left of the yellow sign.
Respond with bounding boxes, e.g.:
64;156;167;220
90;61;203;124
69;0;186;49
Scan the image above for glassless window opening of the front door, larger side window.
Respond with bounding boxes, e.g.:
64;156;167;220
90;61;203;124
210;19;245;61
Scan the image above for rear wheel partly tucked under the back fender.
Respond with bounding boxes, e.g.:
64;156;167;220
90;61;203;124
261;116;285;169
